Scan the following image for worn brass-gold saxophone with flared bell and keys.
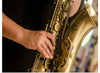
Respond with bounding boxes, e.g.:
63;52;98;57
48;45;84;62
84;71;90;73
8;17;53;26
28;0;98;72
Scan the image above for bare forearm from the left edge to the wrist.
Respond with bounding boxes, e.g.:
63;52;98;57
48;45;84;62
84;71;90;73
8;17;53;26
2;13;25;43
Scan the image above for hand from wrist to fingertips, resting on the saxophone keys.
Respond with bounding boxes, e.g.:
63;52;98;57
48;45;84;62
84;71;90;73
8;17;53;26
20;30;55;58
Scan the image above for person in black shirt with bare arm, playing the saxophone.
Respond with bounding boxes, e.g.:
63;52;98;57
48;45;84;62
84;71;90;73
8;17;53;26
2;0;80;72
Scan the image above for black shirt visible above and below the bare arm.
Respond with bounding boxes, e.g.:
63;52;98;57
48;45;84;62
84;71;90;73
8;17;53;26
2;0;54;72
